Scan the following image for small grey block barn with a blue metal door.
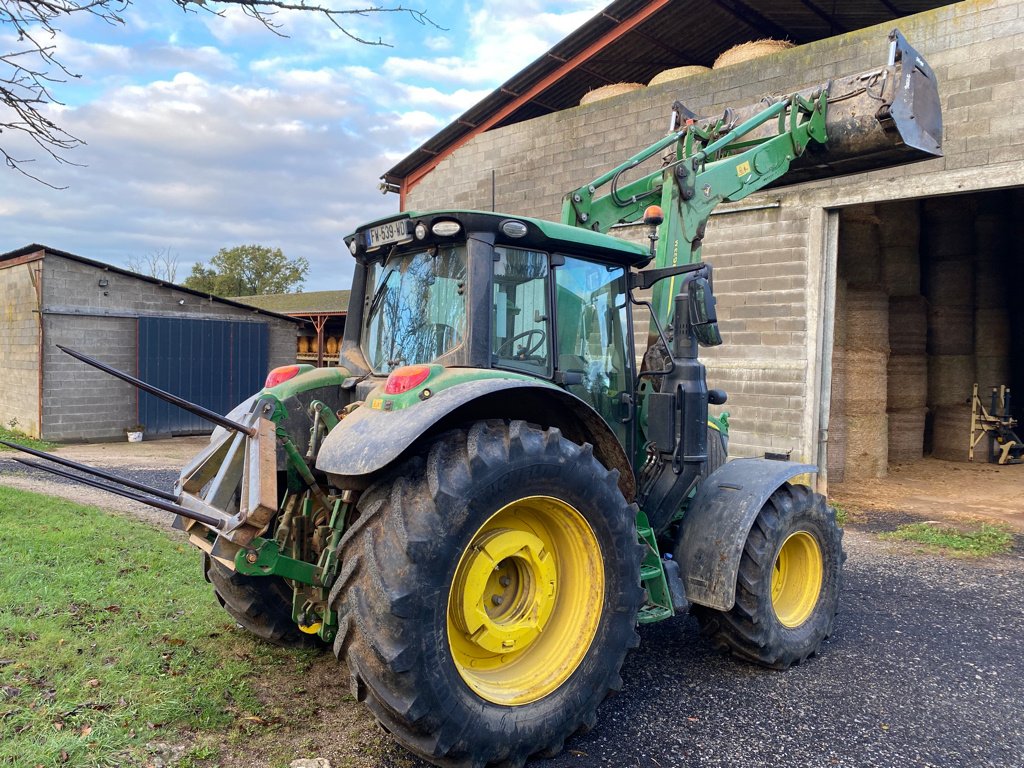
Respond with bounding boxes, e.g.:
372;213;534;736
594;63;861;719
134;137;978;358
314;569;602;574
0;245;302;441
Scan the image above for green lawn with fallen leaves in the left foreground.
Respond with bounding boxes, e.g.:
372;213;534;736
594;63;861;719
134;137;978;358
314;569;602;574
0;486;315;768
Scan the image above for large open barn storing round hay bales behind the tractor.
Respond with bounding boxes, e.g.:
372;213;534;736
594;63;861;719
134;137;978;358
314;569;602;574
384;0;1024;482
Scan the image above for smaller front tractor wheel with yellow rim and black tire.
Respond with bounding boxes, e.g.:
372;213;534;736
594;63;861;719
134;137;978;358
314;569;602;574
691;483;846;670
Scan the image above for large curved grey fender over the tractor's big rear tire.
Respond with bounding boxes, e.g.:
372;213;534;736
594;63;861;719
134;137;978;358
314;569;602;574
316;378;636;501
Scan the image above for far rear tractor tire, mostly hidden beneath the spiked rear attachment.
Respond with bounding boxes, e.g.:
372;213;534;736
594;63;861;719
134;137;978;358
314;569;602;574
203;553;322;648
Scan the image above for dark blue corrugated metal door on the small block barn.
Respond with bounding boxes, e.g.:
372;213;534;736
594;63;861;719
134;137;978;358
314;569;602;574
138;317;267;434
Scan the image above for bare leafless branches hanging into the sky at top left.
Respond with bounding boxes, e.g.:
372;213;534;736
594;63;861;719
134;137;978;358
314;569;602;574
0;0;437;186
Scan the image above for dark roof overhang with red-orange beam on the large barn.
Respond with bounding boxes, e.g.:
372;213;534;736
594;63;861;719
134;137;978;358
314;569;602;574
382;0;952;187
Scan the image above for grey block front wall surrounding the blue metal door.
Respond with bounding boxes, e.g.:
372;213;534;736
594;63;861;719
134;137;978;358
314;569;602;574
42;254;298;440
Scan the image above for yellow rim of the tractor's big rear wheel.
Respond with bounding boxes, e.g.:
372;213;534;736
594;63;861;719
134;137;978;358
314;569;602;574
447;496;604;706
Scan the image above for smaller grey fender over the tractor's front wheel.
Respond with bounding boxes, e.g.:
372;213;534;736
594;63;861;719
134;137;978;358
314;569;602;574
676;459;818;610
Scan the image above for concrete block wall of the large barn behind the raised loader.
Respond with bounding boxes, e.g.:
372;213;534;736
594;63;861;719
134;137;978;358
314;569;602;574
407;0;1024;461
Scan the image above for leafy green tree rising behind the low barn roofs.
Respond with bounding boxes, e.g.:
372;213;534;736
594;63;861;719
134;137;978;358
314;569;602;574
182;245;309;296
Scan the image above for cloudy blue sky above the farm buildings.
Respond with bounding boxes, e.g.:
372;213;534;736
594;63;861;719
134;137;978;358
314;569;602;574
0;0;607;291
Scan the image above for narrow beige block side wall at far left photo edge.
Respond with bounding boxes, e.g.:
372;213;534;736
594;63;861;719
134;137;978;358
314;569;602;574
0;261;42;437
